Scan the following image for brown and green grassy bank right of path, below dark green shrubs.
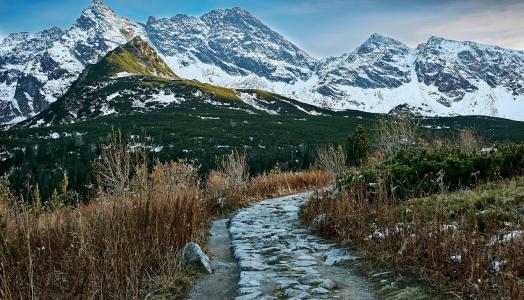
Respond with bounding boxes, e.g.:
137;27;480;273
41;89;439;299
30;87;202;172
302;178;524;299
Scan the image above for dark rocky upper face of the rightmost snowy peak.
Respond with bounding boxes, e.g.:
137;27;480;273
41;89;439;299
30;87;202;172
415;37;524;107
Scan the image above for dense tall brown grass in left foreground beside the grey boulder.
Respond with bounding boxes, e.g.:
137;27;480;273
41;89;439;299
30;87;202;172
0;159;205;299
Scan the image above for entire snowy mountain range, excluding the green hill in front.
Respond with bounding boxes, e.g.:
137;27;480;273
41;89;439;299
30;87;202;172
0;0;524;123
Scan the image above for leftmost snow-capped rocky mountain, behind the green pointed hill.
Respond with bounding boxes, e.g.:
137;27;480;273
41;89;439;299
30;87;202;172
0;0;142;123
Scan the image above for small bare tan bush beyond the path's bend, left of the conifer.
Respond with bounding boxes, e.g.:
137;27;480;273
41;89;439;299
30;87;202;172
314;145;347;179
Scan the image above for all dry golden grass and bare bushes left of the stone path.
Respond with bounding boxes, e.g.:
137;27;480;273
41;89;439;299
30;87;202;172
0;144;329;299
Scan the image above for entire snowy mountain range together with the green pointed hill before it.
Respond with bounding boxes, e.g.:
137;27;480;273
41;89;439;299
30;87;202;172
0;0;524;127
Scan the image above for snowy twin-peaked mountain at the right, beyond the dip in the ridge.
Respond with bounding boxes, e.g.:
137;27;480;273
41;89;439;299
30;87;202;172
294;34;524;120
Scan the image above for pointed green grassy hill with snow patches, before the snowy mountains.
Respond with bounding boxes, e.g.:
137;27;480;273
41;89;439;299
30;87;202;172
19;37;332;127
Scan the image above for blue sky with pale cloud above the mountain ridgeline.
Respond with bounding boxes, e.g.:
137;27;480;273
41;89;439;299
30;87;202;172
0;0;524;58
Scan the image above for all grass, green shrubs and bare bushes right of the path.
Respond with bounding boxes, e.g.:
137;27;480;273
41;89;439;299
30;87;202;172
301;120;524;299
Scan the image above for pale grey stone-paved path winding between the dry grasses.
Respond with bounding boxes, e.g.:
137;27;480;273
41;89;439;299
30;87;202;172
229;193;374;300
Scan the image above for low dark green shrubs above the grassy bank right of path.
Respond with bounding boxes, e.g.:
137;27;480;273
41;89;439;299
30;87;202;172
337;144;524;200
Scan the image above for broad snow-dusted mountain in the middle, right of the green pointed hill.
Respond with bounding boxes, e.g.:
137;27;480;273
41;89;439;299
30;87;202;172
146;7;316;84
